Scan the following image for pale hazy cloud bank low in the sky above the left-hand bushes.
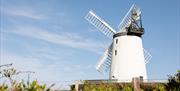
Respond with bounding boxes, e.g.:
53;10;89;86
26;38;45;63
0;49;102;88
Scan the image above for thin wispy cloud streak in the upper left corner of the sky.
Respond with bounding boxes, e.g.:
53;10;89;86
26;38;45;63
1;7;47;20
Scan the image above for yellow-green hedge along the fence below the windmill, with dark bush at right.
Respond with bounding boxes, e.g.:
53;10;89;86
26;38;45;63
71;70;180;91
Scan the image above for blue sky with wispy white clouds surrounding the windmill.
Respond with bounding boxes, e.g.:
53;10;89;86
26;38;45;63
0;0;180;86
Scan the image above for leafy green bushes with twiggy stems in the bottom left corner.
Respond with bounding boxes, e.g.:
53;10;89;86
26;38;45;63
0;68;54;91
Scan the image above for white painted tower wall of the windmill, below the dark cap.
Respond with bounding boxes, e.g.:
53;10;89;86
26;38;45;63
110;35;147;82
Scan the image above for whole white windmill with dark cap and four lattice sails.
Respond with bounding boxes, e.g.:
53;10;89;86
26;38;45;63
85;5;152;82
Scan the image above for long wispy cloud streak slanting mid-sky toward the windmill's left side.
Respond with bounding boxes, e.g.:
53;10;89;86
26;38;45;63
6;27;106;53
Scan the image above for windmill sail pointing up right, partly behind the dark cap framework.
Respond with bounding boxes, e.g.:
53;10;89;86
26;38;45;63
118;4;141;32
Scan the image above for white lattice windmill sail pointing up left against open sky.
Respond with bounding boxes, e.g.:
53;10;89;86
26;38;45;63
85;10;116;38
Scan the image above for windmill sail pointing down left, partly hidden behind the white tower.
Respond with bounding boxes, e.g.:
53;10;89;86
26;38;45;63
96;44;112;73
